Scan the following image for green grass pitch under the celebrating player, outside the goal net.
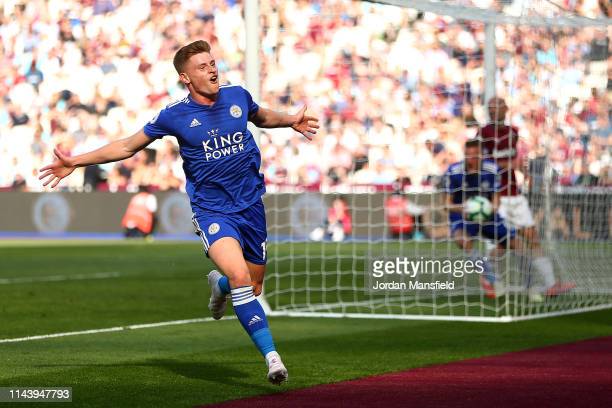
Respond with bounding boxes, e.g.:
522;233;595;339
0;241;612;407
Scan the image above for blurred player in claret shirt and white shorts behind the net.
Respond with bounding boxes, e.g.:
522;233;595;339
479;97;576;299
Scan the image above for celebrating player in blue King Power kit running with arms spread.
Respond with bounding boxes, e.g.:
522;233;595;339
40;40;319;384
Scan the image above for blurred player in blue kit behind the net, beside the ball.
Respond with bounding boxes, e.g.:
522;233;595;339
444;139;518;298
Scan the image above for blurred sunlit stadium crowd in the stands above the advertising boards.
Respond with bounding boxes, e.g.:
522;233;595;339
0;0;612;192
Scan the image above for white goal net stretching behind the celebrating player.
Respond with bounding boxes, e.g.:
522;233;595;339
260;1;612;321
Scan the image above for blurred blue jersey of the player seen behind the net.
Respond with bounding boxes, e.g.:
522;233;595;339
444;160;500;204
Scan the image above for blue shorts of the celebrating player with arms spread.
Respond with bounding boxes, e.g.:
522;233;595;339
192;200;268;265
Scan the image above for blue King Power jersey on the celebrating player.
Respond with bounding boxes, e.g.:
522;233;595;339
144;85;266;214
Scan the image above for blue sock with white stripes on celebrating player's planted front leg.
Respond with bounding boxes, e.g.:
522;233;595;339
231;286;276;357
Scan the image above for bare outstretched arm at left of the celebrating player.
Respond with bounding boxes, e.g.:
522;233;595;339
38;130;153;188
